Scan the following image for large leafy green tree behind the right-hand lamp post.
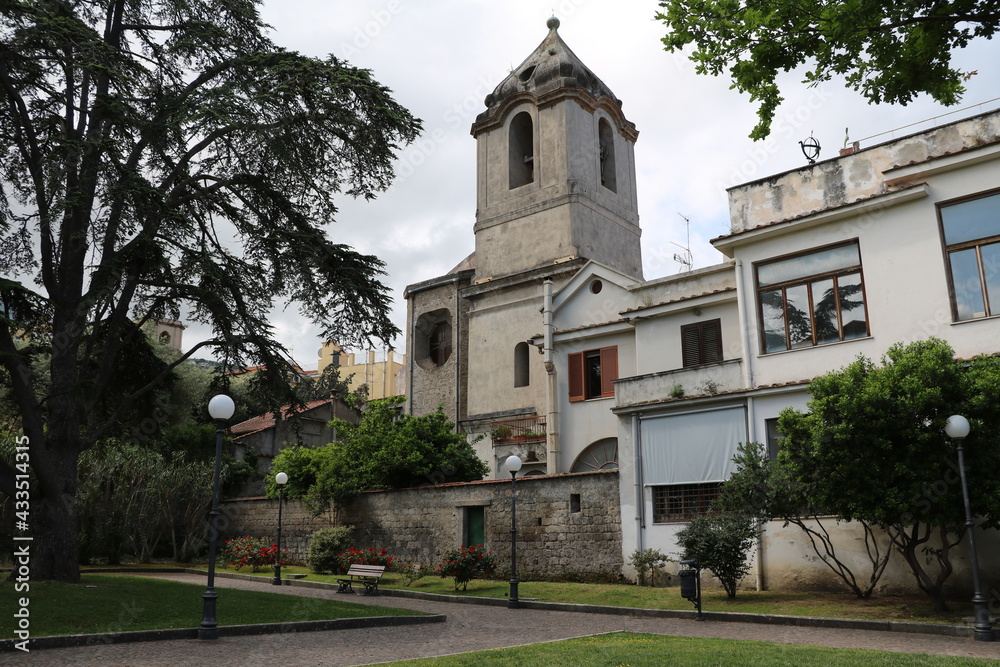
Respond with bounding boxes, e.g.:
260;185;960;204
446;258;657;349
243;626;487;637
779;339;1000;610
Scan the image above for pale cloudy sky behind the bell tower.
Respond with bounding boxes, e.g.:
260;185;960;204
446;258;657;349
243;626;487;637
185;0;1000;368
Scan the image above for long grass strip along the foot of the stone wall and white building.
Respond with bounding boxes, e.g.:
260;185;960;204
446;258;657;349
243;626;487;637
203;566;972;625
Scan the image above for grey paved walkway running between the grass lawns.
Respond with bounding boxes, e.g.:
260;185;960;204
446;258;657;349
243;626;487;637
9;574;1000;667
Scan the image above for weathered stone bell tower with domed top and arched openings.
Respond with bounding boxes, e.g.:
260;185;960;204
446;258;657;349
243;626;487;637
472;17;642;281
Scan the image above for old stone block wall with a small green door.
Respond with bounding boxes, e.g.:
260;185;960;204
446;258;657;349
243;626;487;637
220;471;623;580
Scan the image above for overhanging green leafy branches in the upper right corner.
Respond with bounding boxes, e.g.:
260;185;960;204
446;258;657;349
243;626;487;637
657;0;1000;139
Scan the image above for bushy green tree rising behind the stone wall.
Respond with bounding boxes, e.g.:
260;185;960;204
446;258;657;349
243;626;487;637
267;397;489;514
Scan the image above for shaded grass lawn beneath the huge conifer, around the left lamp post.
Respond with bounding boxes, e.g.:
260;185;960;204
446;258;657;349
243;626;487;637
0;574;420;639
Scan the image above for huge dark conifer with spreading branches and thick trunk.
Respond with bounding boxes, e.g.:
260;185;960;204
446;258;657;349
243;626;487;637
0;0;420;581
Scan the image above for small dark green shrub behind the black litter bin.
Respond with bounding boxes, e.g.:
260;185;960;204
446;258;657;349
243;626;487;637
677;512;759;598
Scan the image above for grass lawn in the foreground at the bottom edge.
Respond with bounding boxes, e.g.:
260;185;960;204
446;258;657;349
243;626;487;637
378;633;996;667
